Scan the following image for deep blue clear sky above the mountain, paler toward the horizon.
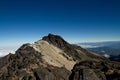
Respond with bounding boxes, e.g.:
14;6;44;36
0;0;120;46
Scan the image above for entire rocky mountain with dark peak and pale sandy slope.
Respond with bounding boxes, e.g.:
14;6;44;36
0;34;120;80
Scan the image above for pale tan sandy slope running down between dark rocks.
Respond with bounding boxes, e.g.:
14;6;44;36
31;40;76;70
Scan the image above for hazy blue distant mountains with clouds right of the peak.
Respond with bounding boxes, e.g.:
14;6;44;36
78;41;120;61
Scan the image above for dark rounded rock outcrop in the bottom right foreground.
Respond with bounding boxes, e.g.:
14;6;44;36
69;61;120;80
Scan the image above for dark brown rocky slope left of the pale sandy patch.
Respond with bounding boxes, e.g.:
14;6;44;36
0;44;70;80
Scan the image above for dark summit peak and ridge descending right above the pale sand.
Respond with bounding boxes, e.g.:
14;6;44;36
43;34;105;62
